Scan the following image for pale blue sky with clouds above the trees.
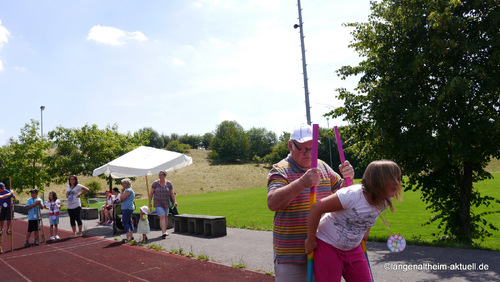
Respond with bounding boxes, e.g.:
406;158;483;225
0;0;370;145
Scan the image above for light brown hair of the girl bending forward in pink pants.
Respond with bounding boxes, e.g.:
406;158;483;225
361;160;402;211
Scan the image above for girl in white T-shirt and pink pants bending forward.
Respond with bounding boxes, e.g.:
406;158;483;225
305;160;401;282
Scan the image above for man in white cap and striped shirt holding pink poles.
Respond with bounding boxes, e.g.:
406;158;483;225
267;124;354;282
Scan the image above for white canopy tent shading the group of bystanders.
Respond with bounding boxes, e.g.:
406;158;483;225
92;146;193;194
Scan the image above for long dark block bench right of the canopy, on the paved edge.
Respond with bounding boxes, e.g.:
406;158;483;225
174;214;227;237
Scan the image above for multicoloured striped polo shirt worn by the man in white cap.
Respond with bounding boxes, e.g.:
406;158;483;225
267;154;342;263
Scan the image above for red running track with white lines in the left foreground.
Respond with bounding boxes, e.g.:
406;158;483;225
0;220;274;281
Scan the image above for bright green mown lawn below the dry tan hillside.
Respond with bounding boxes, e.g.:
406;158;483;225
91;173;500;250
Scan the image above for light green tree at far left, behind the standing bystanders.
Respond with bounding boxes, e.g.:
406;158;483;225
0;120;51;192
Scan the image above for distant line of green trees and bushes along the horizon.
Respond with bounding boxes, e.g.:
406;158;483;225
0;120;363;194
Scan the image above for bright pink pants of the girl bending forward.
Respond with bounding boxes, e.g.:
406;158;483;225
314;238;372;282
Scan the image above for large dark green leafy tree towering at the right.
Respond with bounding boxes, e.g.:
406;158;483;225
332;0;500;244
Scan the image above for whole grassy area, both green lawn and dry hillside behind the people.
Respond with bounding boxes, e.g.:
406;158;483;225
18;150;500;250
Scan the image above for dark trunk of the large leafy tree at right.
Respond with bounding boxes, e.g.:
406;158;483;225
459;163;472;245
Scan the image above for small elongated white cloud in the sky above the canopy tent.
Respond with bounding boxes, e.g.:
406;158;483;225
87;25;148;46
